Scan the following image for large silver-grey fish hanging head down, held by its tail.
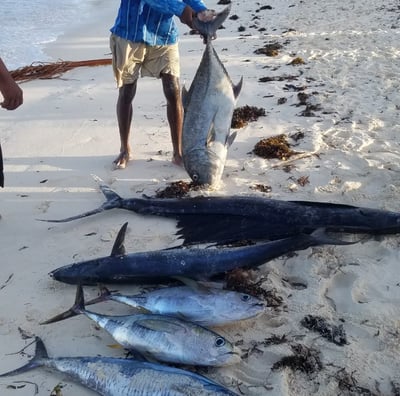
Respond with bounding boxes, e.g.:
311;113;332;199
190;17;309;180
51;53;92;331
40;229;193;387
182;7;242;185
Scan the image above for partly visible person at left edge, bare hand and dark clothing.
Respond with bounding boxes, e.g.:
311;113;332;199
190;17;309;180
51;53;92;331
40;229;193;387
0;58;23;187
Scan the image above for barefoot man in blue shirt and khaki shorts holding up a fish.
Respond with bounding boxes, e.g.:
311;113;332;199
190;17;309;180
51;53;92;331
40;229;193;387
110;0;215;169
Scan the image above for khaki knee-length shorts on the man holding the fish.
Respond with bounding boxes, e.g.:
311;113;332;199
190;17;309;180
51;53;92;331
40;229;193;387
110;34;180;87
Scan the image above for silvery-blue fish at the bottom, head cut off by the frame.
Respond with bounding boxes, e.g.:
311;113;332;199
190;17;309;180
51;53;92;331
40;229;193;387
0;337;237;396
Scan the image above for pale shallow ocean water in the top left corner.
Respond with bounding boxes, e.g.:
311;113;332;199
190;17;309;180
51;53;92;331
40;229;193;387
0;0;96;70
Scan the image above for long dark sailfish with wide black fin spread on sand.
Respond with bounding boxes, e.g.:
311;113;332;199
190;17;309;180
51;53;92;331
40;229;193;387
38;185;400;244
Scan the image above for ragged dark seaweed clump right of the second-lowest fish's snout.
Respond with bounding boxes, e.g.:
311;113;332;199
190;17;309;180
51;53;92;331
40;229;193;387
272;344;322;374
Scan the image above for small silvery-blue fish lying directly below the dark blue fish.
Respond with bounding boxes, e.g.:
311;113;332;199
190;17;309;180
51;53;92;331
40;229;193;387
54;285;265;326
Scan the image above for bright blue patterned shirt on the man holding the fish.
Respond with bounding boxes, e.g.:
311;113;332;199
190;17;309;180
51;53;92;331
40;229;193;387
110;0;207;46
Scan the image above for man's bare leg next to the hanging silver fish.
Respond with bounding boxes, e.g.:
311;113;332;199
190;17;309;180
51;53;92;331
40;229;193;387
161;73;183;165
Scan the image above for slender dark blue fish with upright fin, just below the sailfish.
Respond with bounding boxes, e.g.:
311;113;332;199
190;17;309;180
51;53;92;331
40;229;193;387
49;223;354;285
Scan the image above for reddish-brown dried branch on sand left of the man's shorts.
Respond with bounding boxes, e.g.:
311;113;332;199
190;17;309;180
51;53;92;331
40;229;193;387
10;59;112;82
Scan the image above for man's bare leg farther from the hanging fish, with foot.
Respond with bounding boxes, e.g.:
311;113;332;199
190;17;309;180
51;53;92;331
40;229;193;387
114;80;137;169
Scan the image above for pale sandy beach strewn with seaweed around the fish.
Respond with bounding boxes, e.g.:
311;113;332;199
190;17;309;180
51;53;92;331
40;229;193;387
0;0;400;396
